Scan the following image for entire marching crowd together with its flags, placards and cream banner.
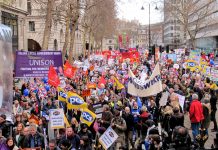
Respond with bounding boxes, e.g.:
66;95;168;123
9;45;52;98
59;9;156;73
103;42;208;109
0;49;215;150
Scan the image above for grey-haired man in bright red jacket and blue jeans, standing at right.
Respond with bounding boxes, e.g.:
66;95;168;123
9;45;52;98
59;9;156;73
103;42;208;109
189;94;204;139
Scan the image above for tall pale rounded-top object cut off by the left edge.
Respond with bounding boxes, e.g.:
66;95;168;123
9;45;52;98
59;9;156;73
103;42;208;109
0;24;14;115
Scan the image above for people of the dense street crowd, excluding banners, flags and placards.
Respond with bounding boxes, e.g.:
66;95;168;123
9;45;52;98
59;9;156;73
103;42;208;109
0;48;218;150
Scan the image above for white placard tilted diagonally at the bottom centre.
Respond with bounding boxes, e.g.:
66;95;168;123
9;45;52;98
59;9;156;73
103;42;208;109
99;127;118;149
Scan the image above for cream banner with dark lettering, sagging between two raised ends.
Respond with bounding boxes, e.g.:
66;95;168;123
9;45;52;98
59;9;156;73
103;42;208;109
128;63;163;97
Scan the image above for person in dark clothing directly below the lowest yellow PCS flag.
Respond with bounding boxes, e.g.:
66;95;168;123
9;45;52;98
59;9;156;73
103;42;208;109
78;123;92;150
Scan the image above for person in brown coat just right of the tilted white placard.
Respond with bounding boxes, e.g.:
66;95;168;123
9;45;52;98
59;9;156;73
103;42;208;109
111;110;127;150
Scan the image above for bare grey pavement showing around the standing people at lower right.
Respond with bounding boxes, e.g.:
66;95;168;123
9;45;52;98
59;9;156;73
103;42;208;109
184;104;218;149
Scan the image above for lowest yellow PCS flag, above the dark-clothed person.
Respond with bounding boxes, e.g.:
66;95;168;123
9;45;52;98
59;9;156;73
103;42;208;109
80;108;96;126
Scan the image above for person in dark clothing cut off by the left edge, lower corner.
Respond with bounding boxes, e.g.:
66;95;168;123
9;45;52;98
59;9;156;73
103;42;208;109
0;114;10;138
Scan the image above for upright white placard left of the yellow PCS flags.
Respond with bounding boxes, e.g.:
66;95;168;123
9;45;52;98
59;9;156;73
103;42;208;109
49;109;64;129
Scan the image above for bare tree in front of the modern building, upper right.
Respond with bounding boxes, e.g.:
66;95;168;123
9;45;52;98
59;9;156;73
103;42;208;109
164;0;214;48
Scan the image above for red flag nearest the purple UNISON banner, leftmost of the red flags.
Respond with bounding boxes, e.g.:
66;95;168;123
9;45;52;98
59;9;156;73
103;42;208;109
48;66;60;87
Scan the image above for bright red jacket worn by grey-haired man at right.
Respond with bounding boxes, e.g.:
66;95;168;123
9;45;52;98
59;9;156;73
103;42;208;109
189;100;204;123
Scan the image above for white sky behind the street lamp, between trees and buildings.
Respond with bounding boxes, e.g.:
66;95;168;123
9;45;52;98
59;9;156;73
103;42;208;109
117;0;163;25
